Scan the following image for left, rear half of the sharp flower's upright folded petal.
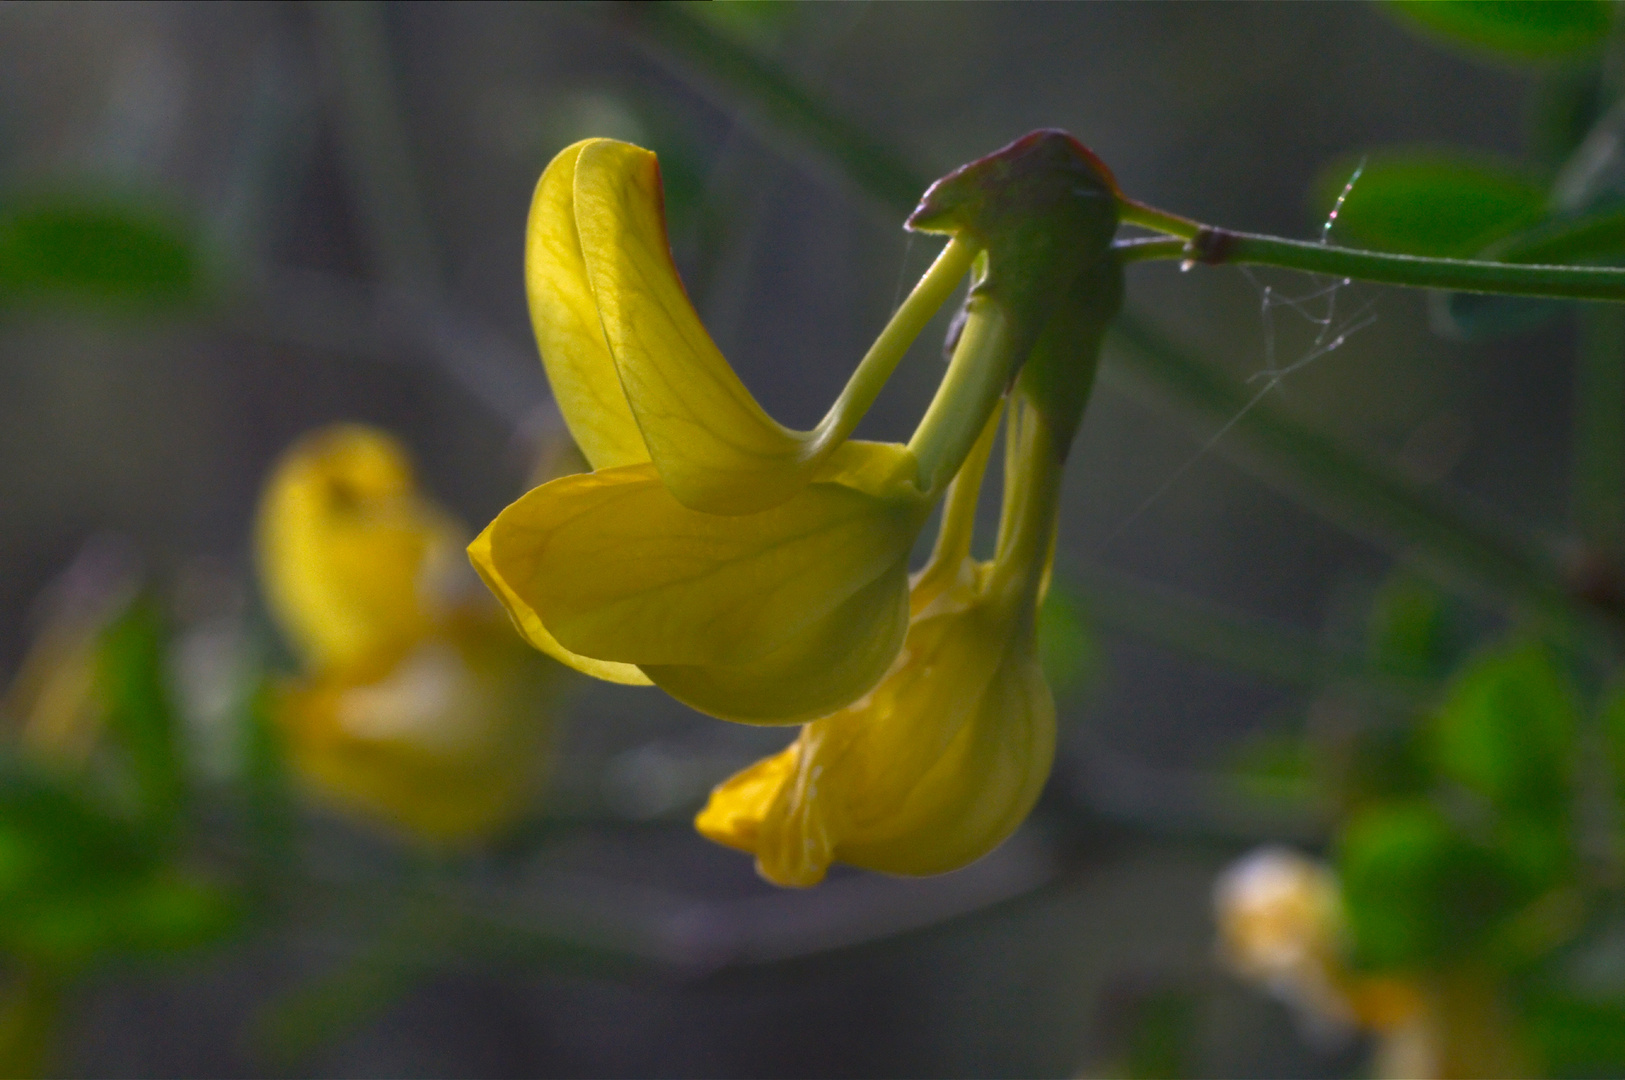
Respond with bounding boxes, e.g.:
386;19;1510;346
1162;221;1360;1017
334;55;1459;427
525;140;648;469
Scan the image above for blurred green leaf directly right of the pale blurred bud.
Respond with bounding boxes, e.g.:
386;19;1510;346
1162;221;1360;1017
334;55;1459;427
1337;802;1526;970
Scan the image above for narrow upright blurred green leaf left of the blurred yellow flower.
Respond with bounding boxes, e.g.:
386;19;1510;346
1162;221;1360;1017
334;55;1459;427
101;598;187;832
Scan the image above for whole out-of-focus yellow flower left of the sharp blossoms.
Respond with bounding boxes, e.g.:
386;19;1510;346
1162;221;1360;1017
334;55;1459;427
257;424;549;843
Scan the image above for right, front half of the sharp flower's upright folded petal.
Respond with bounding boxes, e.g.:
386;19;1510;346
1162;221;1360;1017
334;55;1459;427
575;140;835;515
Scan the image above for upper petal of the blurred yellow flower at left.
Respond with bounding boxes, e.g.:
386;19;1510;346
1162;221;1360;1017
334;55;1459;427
255;424;462;669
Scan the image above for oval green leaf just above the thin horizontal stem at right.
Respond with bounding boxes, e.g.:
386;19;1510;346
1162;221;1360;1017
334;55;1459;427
1313;148;1545;258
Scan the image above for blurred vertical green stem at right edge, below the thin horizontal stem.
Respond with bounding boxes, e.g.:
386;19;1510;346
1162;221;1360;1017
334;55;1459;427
1570;305;1625;551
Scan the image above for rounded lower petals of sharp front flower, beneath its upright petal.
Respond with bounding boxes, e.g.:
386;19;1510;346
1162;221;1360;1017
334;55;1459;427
470;443;928;723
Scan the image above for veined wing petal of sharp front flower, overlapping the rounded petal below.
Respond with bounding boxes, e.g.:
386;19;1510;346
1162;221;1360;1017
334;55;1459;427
489;464;921;666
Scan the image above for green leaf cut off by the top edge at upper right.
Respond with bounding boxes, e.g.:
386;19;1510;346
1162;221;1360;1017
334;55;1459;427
1386;0;1612;62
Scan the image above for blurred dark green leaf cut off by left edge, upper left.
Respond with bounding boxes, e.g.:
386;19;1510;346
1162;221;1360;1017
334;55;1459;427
0;195;200;307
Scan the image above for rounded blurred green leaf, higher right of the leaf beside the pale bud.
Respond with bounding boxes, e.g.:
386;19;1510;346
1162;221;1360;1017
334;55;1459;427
1432;645;1576;817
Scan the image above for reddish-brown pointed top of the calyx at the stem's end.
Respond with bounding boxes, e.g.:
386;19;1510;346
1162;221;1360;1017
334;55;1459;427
905;128;1120;232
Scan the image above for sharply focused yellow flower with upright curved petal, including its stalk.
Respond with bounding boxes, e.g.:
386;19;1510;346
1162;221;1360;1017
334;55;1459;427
470;140;991;723
